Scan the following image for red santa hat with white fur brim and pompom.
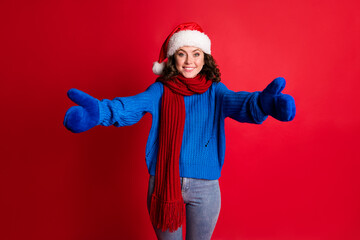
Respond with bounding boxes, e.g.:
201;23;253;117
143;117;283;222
153;22;211;75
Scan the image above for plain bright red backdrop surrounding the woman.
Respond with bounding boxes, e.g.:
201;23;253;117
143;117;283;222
0;0;360;240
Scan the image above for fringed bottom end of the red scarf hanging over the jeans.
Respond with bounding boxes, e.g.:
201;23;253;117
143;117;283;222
150;193;185;232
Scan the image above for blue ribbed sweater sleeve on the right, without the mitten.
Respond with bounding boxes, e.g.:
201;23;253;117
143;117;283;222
216;83;267;124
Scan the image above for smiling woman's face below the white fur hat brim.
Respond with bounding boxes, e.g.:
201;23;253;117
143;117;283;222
175;46;204;78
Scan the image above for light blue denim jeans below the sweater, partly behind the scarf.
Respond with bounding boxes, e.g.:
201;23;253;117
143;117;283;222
147;176;221;240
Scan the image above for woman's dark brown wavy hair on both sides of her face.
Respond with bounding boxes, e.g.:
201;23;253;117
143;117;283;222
162;53;221;82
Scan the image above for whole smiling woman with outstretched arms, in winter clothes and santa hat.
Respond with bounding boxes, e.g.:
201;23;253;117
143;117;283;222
64;23;295;240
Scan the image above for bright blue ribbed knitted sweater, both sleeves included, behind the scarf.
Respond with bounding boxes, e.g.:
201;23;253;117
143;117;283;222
100;82;267;180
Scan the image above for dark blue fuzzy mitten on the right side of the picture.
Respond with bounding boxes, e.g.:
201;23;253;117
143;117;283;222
259;77;296;122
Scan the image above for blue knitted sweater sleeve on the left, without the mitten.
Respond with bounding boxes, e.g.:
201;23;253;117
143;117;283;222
100;83;163;127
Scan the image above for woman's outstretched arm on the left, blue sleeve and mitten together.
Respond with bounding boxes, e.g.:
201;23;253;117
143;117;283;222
64;83;163;133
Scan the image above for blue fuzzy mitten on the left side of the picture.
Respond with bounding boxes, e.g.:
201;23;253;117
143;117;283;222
64;88;100;133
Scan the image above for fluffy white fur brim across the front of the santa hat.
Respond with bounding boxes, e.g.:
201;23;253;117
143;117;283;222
167;30;211;57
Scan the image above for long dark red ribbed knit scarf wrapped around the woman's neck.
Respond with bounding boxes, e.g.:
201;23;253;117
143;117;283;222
150;74;212;232
